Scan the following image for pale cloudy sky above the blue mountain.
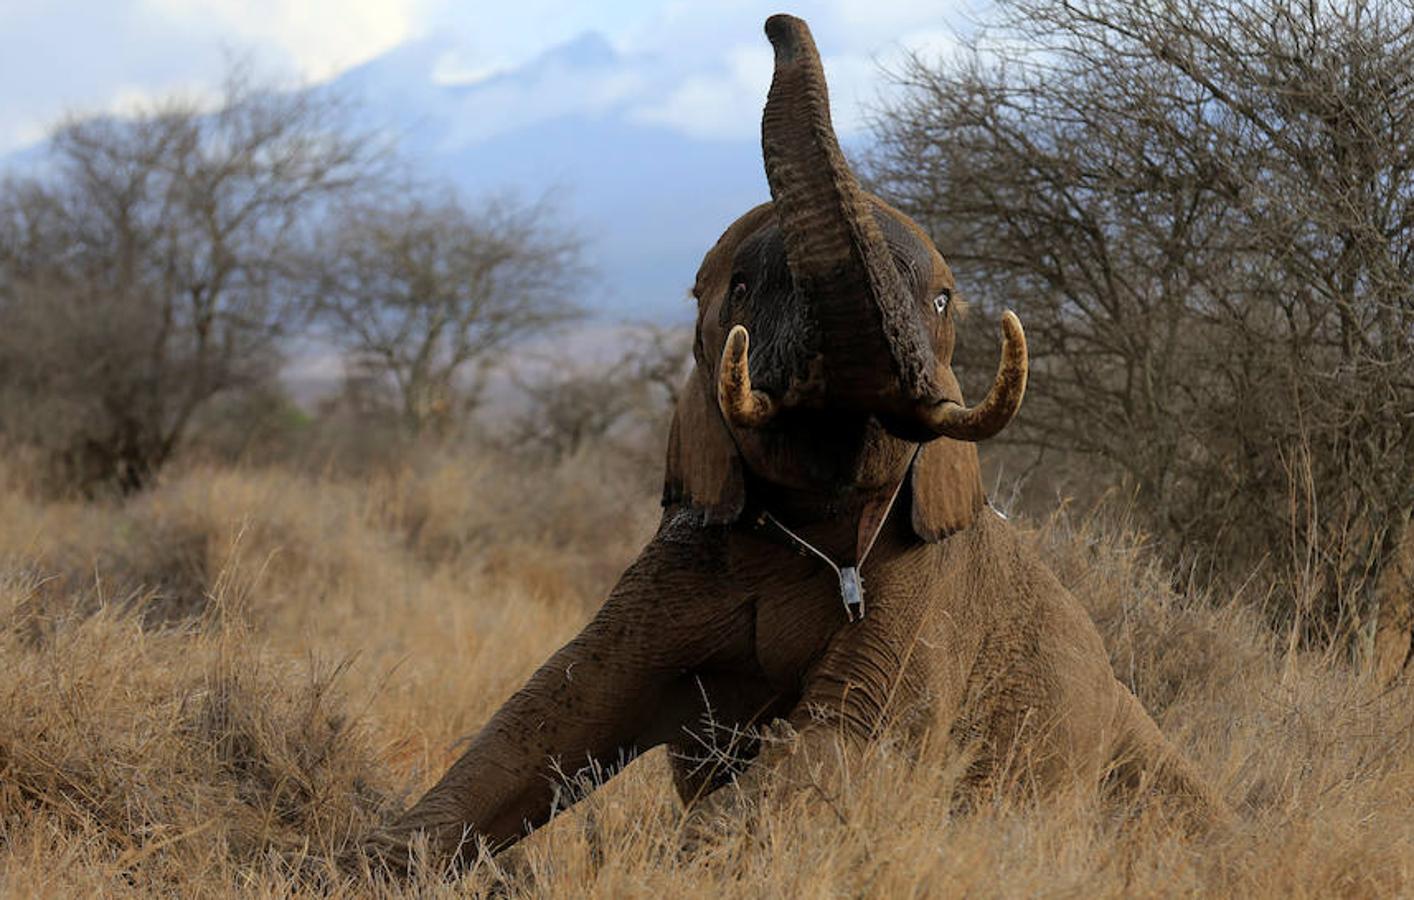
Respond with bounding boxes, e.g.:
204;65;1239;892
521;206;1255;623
0;0;984;153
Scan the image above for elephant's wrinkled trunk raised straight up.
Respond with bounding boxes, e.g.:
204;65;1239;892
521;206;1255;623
761;16;937;409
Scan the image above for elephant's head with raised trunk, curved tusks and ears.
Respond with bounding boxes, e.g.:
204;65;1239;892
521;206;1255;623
665;16;1027;539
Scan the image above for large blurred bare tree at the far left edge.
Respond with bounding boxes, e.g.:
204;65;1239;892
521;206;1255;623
0;74;379;491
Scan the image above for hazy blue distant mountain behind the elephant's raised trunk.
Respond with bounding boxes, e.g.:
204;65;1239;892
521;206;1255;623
334;34;769;321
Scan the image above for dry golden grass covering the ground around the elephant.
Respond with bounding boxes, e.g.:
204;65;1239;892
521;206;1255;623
0;456;1414;897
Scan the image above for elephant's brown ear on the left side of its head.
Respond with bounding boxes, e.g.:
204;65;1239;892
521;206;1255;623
663;367;747;525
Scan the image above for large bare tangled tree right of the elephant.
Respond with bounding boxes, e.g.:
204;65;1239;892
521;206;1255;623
872;0;1414;668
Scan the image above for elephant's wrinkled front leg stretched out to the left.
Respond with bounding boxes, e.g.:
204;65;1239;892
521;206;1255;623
359;538;751;870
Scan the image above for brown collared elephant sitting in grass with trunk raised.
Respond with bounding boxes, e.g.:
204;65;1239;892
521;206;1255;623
365;16;1223;869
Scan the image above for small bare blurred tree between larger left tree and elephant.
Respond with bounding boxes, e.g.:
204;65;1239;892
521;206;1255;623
312;197;581;434
